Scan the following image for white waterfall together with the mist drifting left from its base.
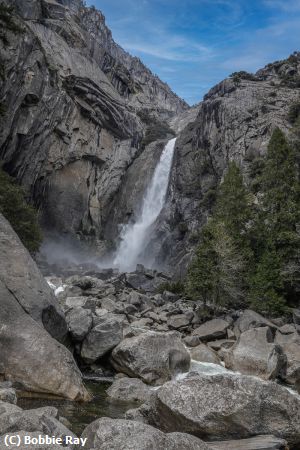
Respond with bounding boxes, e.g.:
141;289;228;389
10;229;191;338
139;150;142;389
38;138;176;272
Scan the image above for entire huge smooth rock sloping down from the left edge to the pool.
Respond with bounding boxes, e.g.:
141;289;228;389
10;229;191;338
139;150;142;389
0;215;89;400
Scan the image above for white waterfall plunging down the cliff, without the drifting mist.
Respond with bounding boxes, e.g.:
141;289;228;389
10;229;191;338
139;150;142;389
114;138;176;272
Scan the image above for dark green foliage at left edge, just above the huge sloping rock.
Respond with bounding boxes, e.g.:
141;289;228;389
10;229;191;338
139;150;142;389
0;168;42;253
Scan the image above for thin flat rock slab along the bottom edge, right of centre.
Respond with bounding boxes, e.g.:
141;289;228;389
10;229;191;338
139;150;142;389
209;435;287;450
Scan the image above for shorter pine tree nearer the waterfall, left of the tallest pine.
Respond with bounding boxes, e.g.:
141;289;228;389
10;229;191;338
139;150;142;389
187;162;251;305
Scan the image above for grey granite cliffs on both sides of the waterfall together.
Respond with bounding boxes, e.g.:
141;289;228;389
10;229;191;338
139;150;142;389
0;0;300;274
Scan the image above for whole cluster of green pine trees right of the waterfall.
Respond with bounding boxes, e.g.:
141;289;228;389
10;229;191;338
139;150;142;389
186;129;300;315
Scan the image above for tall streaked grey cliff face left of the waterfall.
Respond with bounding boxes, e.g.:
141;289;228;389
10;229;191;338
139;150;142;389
0;0;188;249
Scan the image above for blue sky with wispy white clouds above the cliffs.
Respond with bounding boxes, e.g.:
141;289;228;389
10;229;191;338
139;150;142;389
87;0;300;104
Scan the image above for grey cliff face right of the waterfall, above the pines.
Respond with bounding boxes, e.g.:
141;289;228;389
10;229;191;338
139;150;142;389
151;52;300;275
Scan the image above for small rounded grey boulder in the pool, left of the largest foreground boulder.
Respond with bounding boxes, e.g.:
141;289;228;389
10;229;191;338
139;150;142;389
106;377;151;402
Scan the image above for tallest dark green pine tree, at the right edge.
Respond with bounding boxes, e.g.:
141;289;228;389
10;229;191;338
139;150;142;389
249;128;300;313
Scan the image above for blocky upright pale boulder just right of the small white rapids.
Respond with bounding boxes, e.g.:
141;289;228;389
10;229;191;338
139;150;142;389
224;327;286;380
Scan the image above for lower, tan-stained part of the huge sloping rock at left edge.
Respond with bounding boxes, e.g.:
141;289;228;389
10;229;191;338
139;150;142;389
0;281;89;400
